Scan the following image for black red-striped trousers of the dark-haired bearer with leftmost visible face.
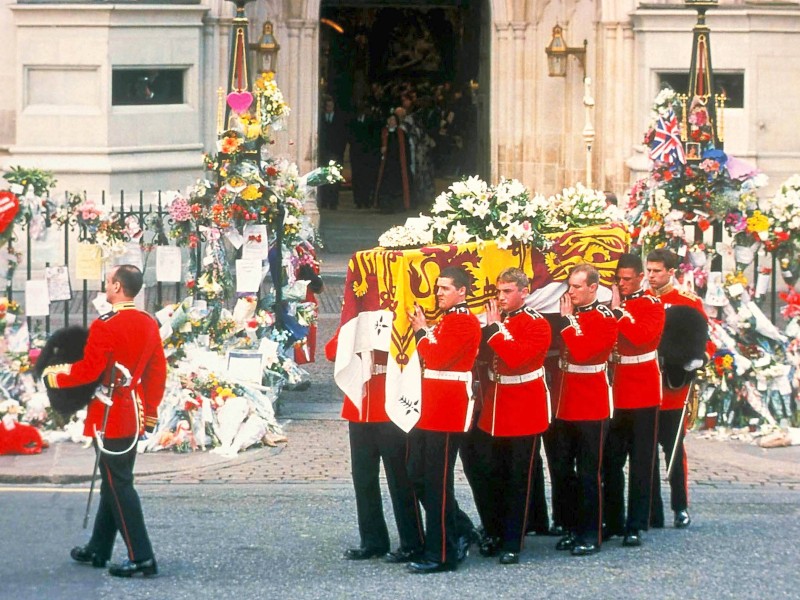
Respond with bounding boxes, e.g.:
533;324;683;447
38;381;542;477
408;429;464;565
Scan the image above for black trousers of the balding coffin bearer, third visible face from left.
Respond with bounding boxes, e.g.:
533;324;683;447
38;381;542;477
548;419;608;546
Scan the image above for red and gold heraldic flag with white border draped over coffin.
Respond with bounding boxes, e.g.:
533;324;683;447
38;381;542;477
334;224;630;431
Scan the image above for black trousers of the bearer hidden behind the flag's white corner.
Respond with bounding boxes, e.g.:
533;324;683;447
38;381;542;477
350;422;424;552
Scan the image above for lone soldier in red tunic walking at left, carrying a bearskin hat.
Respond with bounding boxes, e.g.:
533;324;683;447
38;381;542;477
43;265;167;577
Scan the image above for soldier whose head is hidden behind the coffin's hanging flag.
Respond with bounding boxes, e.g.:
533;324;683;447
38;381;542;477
325;331;424;563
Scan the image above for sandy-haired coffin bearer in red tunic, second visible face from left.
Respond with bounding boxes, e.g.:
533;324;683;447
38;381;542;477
478;267;550;564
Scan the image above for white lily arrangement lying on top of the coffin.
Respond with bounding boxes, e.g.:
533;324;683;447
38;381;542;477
379;176;622;249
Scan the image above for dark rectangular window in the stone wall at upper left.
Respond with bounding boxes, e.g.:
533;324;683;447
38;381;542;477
111;68;186;106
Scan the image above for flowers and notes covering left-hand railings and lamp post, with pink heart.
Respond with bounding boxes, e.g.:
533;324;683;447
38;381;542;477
0;76;342;454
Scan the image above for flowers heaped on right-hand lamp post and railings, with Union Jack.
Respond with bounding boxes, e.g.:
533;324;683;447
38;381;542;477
627;89;800;427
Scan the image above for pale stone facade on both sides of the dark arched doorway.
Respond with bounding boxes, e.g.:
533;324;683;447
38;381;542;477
0;0;800;194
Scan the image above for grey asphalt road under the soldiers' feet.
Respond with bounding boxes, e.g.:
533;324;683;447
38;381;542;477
0;482;800;600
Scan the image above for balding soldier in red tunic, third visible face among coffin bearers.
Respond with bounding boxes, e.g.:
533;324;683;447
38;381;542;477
548;263;617;556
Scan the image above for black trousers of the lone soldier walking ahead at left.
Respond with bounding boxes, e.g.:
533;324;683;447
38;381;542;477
87;438;153;561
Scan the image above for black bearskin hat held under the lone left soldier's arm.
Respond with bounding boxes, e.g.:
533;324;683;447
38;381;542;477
33;325;97;417
